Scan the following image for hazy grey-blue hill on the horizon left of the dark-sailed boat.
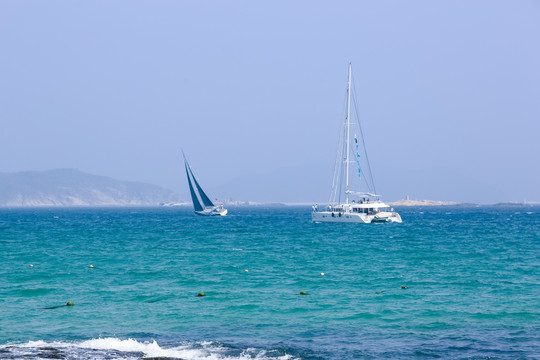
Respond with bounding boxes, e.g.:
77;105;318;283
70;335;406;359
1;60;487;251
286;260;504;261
0;169;180;207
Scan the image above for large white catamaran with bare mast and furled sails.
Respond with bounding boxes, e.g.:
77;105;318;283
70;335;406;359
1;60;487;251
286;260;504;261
311;63;401;223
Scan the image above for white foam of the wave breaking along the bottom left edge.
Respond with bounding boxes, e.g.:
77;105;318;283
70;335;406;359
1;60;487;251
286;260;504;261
0;338;294;360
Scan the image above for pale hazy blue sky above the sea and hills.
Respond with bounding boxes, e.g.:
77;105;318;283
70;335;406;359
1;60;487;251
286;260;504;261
0;0;540;203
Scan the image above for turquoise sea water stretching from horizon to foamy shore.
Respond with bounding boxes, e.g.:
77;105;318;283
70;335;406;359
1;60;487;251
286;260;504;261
0;207;540;359
